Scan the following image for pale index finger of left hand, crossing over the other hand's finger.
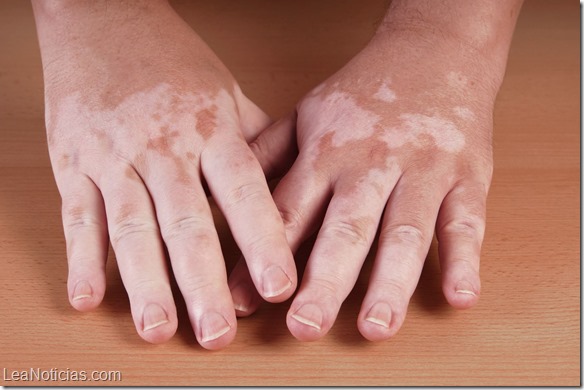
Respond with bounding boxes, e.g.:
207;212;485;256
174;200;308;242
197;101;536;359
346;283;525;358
201;138;297;302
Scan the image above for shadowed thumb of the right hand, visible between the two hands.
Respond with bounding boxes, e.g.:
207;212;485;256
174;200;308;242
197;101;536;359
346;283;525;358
249;111;298;180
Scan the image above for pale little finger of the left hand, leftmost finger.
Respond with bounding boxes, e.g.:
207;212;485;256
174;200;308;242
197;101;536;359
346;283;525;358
59;174;108;311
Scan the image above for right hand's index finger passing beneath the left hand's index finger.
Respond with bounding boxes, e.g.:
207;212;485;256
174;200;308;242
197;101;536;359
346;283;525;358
229;156;332;316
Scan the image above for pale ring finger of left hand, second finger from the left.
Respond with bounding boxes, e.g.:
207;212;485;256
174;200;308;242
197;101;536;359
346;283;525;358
98;163;177;343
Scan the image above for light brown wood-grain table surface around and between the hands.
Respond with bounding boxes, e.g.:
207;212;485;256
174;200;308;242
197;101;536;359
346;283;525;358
0;0;581;385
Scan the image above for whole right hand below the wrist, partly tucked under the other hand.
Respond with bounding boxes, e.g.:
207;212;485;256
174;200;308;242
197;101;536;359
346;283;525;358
229;2;520;340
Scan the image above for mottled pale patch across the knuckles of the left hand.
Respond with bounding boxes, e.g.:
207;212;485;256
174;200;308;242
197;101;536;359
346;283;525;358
48;84;235;185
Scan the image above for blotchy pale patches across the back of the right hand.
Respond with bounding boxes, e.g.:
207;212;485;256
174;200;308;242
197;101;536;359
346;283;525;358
299;83;466;204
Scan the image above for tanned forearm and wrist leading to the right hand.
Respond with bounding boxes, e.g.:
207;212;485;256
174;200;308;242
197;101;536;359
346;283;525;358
374;0;523;89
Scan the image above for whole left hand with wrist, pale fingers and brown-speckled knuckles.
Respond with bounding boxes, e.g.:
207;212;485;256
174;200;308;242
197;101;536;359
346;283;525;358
34;1;296;349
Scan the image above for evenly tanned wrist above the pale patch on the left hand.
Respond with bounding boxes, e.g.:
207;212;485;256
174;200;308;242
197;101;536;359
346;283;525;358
32;0;215;96
